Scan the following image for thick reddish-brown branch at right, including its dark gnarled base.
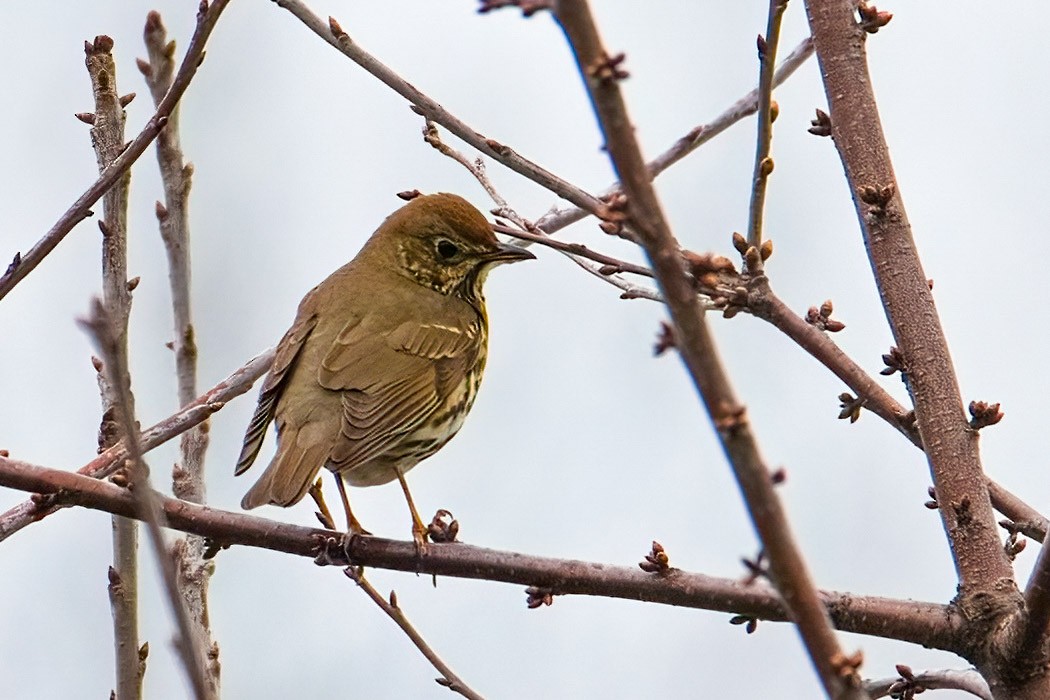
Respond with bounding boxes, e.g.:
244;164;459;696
805;0;1050;698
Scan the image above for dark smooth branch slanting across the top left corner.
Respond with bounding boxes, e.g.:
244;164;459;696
0;0;230;299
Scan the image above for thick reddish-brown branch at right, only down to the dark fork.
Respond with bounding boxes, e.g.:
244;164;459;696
805;0;1016;596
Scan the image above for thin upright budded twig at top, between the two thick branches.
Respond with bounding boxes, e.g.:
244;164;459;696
748;0;788;259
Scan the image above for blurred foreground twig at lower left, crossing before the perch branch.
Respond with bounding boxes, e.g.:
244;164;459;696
81;299;213;700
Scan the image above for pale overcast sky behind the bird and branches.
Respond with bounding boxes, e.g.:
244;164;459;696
0;0;1050;699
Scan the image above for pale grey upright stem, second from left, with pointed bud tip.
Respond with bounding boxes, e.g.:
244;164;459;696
138;10;219;696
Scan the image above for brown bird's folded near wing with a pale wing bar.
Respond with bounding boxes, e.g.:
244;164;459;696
318;322;478;471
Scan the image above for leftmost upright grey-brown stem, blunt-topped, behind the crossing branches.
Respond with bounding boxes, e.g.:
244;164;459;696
84;36;145;700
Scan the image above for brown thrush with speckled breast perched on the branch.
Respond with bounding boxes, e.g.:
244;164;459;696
234;194;534;546
